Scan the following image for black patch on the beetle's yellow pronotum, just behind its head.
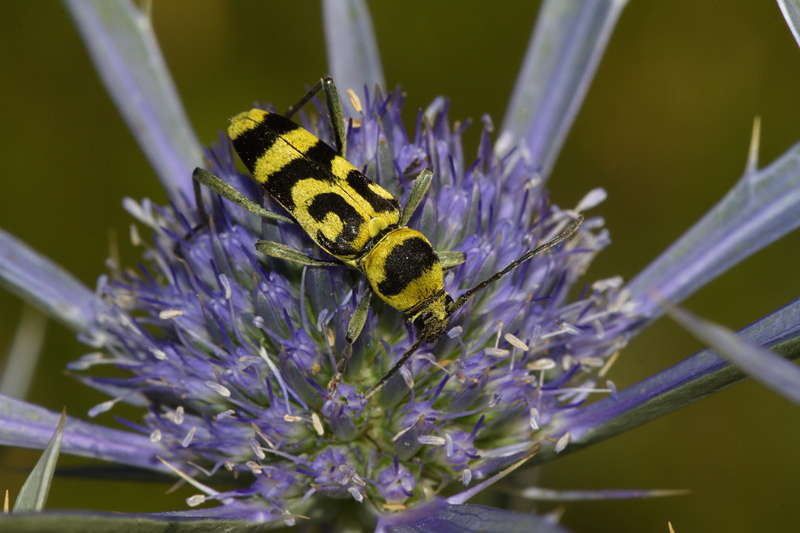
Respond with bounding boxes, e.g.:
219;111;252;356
378;237;439;296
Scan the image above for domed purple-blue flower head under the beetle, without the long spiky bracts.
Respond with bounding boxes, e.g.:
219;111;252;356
81;79;620;516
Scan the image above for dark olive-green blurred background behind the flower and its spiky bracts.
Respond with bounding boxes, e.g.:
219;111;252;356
0;0;800;533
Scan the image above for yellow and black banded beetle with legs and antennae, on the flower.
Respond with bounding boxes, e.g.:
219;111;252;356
194;77;583;399
